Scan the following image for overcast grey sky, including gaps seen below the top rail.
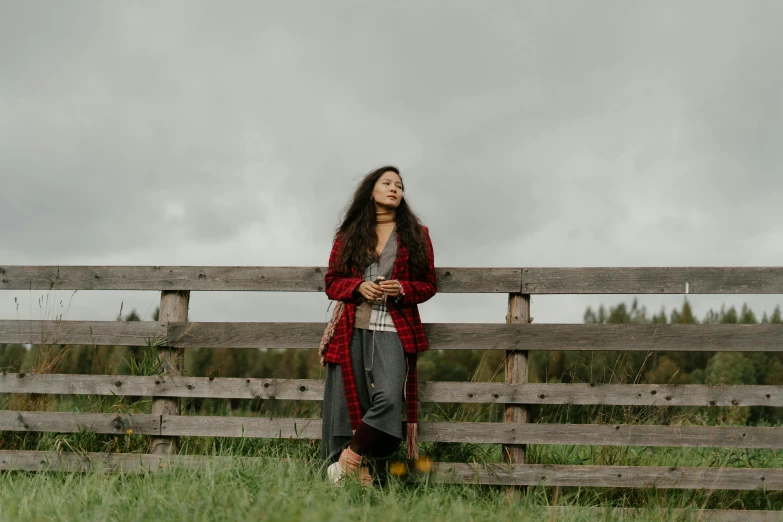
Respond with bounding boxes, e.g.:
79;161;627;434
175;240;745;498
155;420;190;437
0;0;783;322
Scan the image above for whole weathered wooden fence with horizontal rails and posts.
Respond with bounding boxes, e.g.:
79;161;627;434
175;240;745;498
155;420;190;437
0;266;783;504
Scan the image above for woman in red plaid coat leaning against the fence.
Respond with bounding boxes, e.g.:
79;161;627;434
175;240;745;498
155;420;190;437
321;167;436;485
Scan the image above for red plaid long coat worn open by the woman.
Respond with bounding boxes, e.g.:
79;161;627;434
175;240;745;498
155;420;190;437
324;223;437;458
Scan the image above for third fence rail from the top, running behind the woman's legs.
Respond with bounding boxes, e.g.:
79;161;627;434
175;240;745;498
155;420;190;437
0;373;783;407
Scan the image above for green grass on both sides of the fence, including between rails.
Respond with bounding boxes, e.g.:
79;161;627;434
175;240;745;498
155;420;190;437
0;426;783;522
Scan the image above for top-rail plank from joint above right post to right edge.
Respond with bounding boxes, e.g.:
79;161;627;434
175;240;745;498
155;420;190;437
522;267;783;294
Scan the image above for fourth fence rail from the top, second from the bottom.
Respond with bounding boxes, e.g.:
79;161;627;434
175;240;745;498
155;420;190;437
0;410;783;449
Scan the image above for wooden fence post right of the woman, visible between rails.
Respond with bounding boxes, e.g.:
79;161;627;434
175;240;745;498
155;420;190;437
503;293;530;464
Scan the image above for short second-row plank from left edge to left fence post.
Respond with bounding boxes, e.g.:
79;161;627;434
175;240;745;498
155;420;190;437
0;320;166;346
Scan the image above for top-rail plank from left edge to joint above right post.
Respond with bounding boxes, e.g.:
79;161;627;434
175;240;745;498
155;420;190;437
0;265;522;293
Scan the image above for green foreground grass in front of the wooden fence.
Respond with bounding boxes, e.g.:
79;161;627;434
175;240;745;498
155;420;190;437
0;446;760;522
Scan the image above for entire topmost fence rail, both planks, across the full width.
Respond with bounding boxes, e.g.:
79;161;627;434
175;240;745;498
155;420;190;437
0;265;783;294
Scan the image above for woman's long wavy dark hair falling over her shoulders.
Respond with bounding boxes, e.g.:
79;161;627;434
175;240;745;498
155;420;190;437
335;165;429;274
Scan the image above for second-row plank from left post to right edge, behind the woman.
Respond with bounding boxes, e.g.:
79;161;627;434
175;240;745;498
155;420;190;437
168;322;783;352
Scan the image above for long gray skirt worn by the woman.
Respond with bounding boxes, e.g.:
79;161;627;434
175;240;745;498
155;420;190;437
321;328;405;460
